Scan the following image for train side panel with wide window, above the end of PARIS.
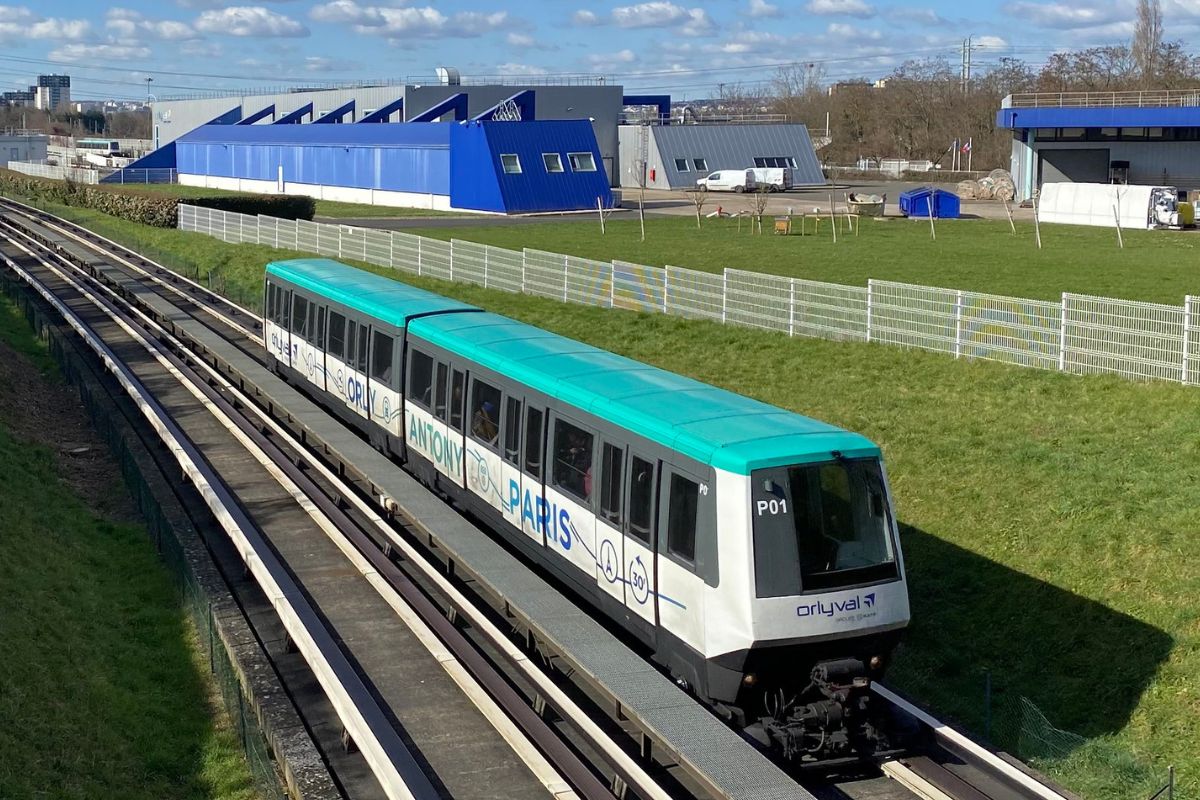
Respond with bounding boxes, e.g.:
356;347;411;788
542;414;599;581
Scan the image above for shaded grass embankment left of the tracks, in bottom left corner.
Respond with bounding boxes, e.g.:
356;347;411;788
0;299;257;800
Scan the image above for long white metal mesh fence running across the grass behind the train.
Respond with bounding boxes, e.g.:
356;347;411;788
179;205;1200;385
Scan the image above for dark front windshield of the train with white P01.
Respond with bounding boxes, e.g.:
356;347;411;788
750;459;899;597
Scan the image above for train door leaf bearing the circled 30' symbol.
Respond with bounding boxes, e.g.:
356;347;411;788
622;452;659;625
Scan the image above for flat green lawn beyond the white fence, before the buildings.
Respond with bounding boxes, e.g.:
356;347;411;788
406;214;1200;305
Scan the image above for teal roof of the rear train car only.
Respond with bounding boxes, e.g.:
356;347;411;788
266;258;480;327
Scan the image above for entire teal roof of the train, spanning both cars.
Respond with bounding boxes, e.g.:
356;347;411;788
269;259;880;475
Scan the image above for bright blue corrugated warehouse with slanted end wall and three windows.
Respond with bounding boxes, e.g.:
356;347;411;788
175;120;612;213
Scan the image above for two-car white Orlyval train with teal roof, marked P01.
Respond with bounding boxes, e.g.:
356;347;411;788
263;258;910;763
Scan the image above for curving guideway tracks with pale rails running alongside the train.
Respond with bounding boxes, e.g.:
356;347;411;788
0;200;1069;800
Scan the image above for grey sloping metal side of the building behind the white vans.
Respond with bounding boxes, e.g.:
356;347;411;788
649;124;826;186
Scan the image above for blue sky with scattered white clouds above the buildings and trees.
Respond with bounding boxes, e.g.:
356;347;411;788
0;0;1200;100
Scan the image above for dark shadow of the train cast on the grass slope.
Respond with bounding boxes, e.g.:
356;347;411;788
889;525;1174;751
